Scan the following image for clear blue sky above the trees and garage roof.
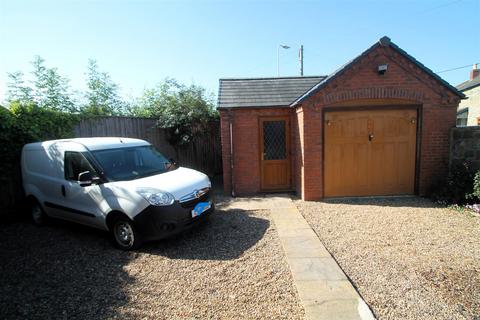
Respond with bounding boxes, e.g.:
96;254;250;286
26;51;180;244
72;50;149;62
0;0;480;101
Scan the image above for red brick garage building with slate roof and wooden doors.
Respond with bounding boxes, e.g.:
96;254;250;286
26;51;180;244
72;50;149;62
218;37;464;200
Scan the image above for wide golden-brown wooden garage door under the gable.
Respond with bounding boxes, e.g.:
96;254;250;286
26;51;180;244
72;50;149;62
324;109;417;197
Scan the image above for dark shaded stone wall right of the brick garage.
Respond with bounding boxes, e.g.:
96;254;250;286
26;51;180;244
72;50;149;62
450;126;480;170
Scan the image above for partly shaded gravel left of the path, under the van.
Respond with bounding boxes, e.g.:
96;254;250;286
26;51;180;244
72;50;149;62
0;210;304;319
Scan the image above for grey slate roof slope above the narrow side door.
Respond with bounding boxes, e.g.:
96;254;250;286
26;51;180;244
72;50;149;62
218;76;326;109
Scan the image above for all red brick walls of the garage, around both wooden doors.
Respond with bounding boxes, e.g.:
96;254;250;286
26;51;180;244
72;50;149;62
220;43;459;200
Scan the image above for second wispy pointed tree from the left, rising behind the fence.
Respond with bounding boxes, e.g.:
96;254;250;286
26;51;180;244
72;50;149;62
82;59;127;116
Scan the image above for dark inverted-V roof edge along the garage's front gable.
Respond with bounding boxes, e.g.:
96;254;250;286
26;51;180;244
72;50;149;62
291;36;465;106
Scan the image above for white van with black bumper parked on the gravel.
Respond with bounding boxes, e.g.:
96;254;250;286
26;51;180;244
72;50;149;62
22;138;214;250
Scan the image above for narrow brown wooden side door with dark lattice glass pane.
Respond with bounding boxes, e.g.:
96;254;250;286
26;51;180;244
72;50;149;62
259;117;291;191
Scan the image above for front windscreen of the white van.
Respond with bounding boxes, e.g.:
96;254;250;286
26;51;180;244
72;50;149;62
92;146;171;181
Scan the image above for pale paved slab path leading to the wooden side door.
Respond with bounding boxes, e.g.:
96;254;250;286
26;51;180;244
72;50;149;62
219;195;375;320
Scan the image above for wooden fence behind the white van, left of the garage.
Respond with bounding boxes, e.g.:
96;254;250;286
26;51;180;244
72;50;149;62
75;117;222;176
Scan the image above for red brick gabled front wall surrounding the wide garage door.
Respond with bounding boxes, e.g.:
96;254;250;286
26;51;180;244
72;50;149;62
300;47;459;200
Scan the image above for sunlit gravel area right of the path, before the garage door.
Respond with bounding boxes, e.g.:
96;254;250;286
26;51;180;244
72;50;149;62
295;197;480;319
